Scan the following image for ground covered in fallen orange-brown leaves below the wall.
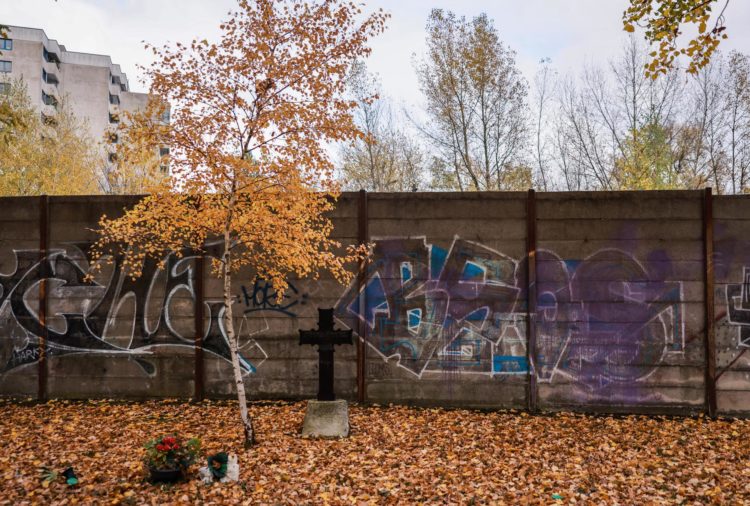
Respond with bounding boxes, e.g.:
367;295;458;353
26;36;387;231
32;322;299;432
0;402;750;504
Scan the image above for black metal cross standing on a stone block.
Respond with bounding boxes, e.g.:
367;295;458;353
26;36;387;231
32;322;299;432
299;309;352;401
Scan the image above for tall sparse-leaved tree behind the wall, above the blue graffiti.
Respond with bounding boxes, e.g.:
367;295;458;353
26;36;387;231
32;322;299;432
416;9;530;191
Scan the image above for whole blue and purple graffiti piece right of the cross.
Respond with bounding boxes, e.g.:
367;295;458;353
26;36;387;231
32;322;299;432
336;237;685;388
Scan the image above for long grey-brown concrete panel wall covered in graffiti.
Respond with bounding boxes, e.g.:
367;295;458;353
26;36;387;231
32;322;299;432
0;192;750;414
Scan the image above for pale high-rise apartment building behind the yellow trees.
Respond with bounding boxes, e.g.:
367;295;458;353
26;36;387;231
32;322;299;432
0;26;166;161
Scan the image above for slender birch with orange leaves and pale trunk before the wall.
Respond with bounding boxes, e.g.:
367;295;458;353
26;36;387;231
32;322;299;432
89;0;387;444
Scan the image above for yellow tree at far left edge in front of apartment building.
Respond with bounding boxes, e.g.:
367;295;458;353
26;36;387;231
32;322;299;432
0;80;100;195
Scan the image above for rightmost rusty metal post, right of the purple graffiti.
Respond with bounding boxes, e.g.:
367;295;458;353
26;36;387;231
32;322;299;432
703;188;716;417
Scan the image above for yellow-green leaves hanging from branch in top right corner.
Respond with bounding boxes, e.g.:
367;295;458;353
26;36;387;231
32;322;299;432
623;0;729;78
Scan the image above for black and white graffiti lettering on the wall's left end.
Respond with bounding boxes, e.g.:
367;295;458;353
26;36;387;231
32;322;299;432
0;244;267;375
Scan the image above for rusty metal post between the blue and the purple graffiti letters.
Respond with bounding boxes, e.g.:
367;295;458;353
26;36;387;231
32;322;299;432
526;190;537;413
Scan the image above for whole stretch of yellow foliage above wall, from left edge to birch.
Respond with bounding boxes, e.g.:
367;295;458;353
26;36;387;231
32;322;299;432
0;79;164;196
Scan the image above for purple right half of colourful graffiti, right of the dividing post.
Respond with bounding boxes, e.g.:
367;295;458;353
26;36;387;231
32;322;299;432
536;249;685;388
